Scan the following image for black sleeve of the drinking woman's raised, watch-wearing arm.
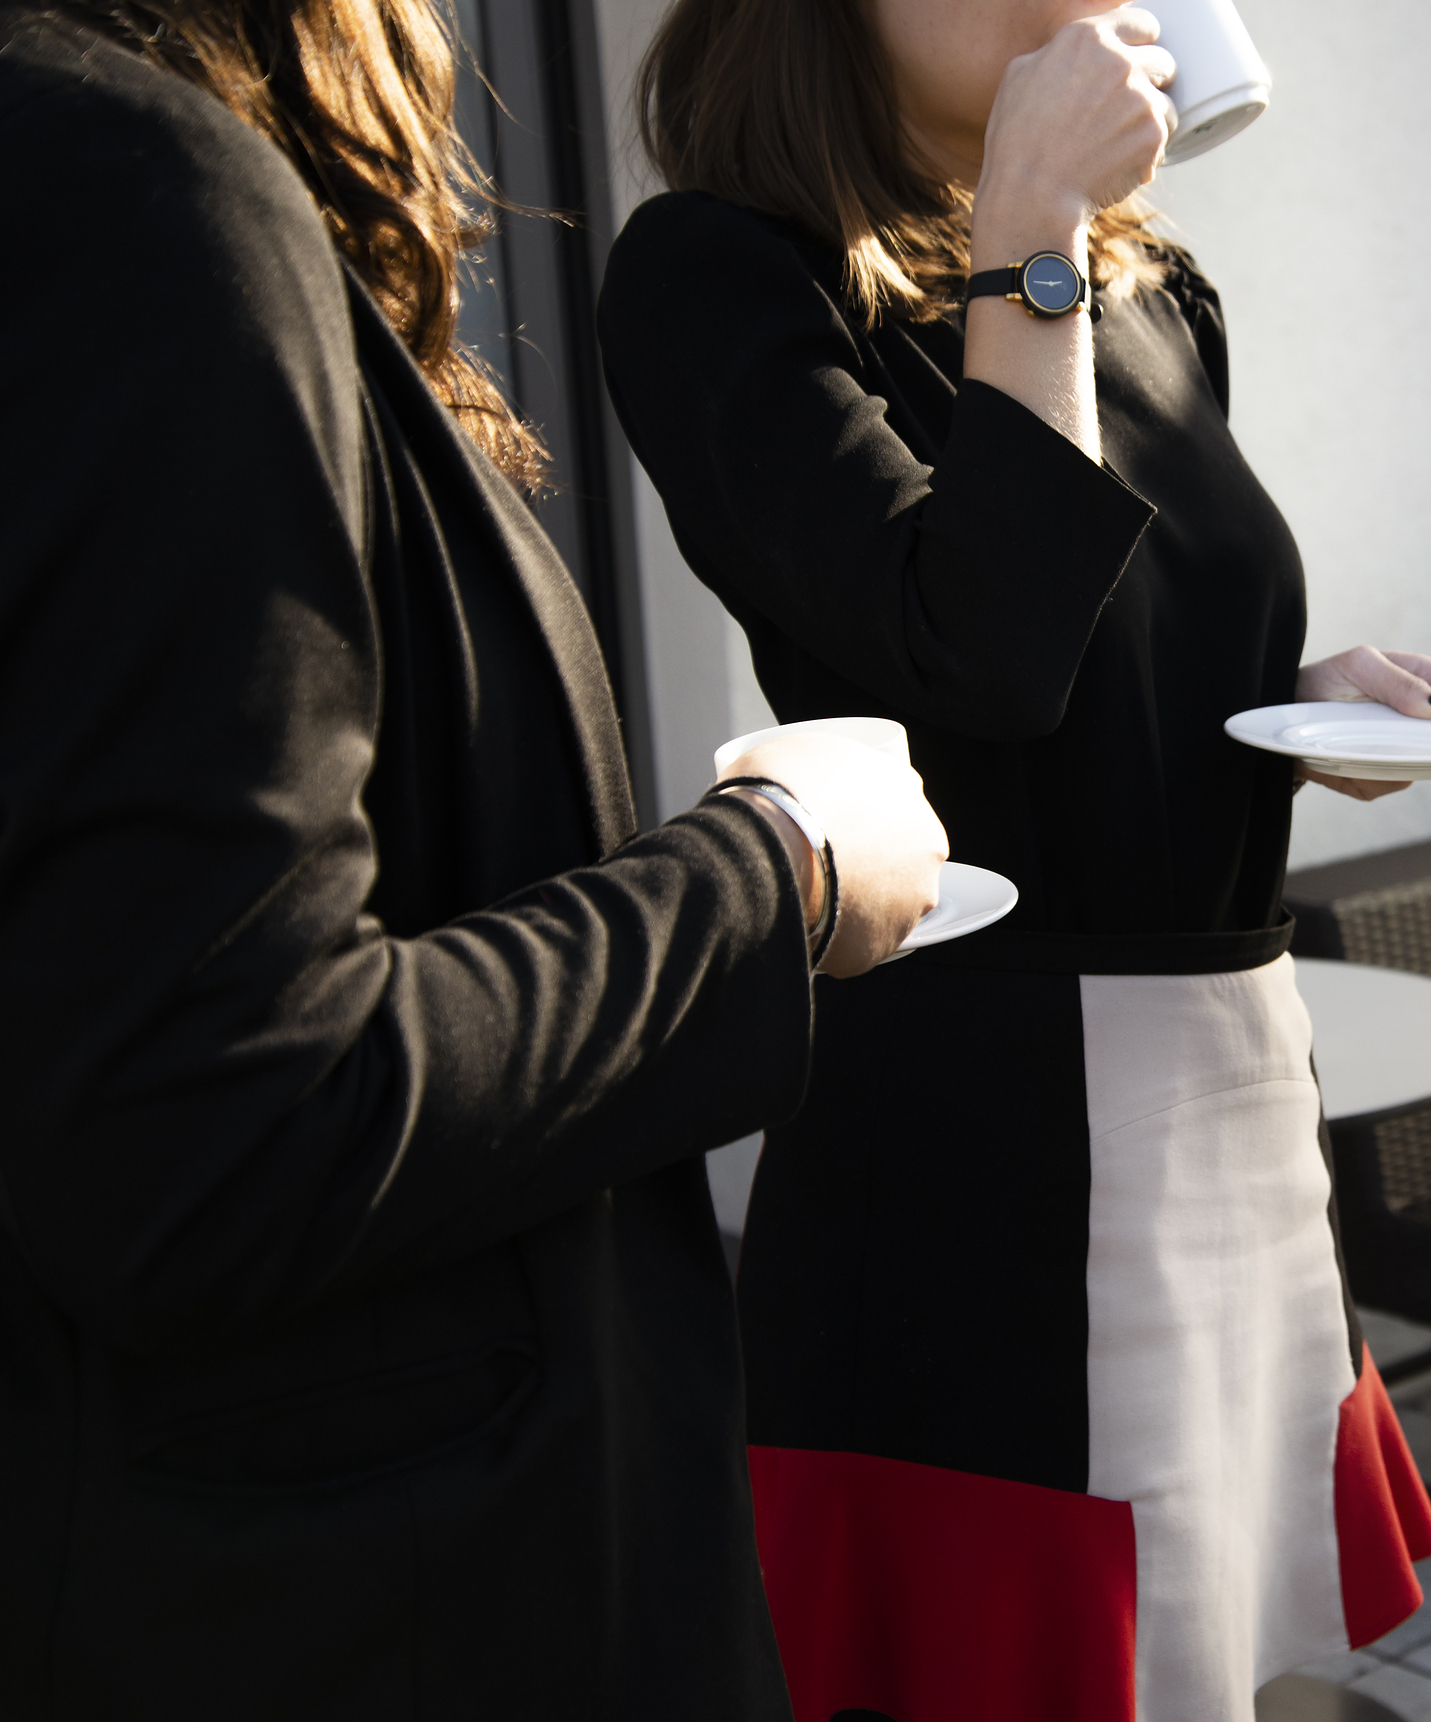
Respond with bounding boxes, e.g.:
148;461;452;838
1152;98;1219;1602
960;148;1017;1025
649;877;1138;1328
599;195;1154;739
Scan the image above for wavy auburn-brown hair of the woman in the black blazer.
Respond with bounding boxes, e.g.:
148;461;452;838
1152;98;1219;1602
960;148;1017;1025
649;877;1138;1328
62;0;546;491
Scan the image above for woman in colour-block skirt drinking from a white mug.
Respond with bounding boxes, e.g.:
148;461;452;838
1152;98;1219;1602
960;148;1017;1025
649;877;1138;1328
601;0;1431;1722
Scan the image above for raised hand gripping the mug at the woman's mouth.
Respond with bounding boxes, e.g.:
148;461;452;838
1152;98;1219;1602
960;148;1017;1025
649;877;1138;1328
975;7;1178;241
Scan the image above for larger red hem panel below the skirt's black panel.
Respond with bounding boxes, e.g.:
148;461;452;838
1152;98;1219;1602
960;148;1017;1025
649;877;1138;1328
751;1446;1138;1722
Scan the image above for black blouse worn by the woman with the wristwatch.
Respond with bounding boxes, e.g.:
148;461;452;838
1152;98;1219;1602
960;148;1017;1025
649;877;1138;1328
599;193;1305;968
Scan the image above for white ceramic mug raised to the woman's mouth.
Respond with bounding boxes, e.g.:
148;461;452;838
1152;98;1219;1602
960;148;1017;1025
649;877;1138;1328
1145;0;1273;165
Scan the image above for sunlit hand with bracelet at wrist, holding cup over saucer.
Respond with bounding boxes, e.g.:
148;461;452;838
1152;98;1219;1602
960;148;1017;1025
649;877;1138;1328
720;730;949;980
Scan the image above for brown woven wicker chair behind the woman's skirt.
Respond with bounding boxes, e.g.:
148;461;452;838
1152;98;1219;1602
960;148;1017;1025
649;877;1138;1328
1286;844;1431;1322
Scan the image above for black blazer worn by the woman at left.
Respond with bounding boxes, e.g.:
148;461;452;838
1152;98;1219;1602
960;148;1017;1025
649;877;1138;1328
0;10;809;1722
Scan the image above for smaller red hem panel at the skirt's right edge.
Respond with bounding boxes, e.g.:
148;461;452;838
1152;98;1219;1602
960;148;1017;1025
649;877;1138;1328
1336;1348;1431;1650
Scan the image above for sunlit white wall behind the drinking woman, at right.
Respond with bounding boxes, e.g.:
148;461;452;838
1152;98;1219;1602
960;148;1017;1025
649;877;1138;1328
1149;0;1431;866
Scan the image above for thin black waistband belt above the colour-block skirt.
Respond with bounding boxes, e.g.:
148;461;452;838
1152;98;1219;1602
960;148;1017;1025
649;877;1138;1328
904;914;1297;975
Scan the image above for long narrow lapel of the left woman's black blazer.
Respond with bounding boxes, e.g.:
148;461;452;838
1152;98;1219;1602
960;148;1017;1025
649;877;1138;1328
344;260;635;856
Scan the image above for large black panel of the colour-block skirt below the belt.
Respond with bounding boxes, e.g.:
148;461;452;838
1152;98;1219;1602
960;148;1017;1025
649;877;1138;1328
739;959;1090;1491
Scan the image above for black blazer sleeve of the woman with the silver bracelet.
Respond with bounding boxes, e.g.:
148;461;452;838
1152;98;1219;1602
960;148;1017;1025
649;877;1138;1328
0;60;809;1352
